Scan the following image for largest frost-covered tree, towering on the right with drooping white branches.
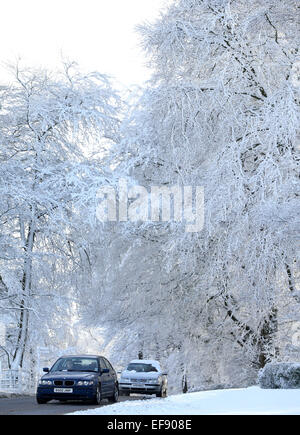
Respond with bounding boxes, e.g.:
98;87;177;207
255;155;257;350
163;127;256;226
81;0;300;392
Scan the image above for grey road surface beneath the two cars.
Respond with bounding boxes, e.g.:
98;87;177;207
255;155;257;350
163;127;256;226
0;396;143;415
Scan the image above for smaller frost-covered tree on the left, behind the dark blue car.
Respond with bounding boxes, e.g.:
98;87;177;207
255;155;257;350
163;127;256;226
0;63;120;368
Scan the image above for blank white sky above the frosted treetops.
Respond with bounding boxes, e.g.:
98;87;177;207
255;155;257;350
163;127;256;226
0;0;165;86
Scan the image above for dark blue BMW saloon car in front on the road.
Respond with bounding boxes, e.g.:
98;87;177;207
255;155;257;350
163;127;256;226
36;355;119;405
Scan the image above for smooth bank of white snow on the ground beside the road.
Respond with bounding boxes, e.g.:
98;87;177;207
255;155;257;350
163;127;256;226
69;387;300;415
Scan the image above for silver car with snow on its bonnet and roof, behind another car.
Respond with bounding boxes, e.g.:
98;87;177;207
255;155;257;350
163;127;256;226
119;359;168;397
